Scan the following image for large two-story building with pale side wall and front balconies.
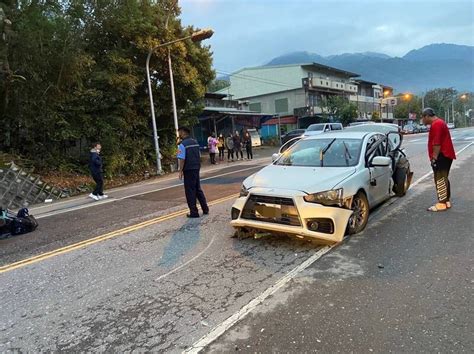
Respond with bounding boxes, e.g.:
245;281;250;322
218;63;359;136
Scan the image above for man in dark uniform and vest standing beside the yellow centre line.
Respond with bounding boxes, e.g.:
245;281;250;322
177;127;209;218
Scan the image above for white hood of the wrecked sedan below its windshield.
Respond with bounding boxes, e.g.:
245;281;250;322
244;165;356;193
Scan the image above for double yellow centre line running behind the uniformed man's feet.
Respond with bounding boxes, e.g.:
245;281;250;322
0;194;239;274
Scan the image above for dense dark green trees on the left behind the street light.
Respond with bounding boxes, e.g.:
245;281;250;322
0;0;214;175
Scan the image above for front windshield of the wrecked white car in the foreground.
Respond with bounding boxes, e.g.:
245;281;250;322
275;138;362;167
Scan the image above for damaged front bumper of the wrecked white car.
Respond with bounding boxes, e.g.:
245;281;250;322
231;189;352;242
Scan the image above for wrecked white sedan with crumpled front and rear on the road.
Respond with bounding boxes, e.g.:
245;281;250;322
231;131;411;242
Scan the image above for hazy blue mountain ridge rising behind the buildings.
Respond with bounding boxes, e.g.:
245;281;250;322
266;44;474;93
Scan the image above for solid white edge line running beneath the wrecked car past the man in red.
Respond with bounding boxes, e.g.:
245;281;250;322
184;142;474;354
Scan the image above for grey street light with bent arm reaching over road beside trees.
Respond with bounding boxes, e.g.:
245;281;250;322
146;28;214;174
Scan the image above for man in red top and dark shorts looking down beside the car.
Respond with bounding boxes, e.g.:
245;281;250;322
422;108;456;212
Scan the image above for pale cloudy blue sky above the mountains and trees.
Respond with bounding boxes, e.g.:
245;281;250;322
179;0;474;76
